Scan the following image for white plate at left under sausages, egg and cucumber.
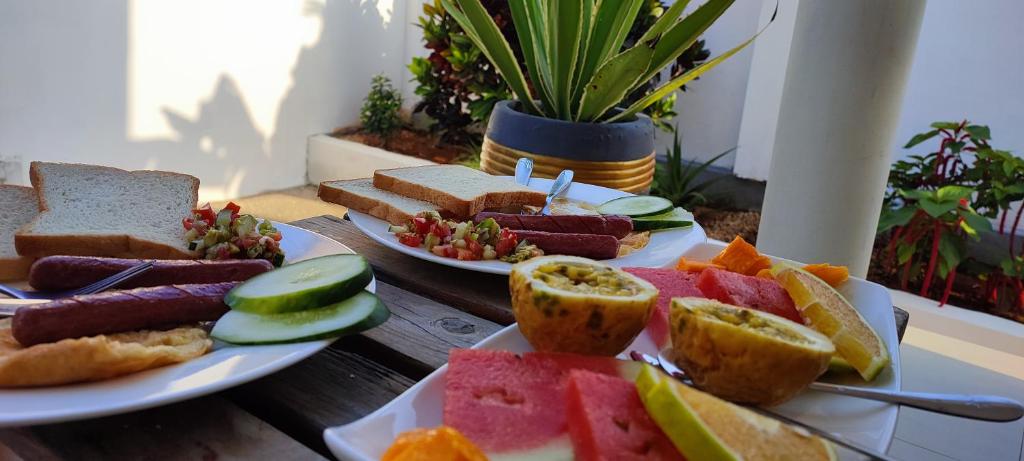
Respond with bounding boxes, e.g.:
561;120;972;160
0;223;376;426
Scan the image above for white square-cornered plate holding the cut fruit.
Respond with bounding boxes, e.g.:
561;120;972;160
324;243;900;461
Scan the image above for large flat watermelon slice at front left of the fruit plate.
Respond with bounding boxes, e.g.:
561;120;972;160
443;349;641;460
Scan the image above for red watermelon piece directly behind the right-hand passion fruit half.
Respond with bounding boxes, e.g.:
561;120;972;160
697;268;804;325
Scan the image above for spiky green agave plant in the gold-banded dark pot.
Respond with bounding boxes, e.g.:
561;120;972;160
441;0;774;122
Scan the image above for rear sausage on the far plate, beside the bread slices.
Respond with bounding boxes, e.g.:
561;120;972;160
473;211;633;239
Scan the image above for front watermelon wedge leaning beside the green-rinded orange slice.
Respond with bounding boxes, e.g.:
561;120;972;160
566;370;683;461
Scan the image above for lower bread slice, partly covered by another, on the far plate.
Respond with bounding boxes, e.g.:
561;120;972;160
316;177;440;225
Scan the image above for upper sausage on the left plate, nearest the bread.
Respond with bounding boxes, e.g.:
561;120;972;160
29;256;273;291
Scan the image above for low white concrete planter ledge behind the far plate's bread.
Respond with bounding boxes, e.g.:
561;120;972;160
306;134;434;185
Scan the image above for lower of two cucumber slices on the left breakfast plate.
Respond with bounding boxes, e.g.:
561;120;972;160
210;291;391;344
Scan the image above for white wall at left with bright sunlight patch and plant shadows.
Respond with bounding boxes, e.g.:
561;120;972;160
0;0;419;200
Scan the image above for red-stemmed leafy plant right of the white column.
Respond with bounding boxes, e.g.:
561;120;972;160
879;120;1024;317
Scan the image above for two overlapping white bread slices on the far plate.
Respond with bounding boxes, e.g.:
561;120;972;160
318;165;546;224
